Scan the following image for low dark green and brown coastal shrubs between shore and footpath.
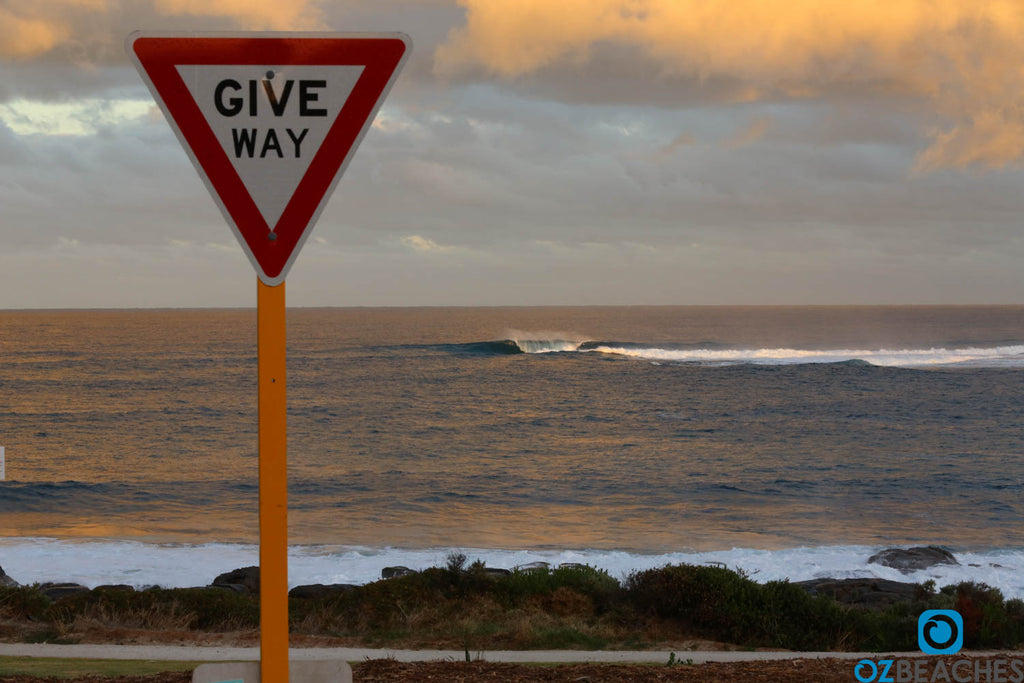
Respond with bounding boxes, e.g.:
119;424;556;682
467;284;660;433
0;556;1024;656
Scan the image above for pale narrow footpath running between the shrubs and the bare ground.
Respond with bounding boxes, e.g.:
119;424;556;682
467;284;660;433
0;643;946;664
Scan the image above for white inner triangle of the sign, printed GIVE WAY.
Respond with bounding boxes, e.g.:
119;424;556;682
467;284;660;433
177;65;364;230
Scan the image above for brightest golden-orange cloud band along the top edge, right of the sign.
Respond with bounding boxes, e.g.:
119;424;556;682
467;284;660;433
436;0;950;81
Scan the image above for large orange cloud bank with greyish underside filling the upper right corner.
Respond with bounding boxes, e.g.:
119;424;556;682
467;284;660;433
434;0;1024;170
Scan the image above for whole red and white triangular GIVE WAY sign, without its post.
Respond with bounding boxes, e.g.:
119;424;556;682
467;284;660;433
127;32;412;286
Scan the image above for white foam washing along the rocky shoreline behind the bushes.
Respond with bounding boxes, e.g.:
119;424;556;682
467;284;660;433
0;538;1024;598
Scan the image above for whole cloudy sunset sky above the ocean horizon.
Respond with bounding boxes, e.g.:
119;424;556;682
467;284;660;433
0;0;1024;309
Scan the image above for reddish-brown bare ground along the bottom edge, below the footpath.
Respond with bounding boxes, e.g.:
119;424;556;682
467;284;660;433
2;655;1009;683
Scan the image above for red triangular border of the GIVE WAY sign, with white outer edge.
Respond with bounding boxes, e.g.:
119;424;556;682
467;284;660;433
126;32;412;287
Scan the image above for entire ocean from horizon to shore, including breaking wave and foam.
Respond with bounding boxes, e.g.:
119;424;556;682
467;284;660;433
0;306;1024;597
